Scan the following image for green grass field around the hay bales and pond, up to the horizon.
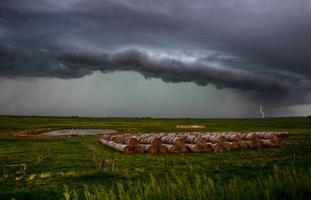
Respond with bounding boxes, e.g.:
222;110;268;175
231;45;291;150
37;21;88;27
0;116;311;199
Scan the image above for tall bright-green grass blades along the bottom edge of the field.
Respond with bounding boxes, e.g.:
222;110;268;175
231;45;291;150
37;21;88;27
63;166;311;200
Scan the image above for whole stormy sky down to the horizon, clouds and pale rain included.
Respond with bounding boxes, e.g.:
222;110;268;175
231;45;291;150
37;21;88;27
0;0;311;118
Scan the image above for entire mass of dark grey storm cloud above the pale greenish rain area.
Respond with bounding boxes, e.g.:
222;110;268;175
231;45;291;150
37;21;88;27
0;0;311;97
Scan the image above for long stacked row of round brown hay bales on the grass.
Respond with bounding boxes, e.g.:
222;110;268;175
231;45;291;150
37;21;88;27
100;132;288;153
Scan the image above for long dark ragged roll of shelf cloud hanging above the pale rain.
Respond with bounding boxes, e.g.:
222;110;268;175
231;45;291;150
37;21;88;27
0;45;297;93
